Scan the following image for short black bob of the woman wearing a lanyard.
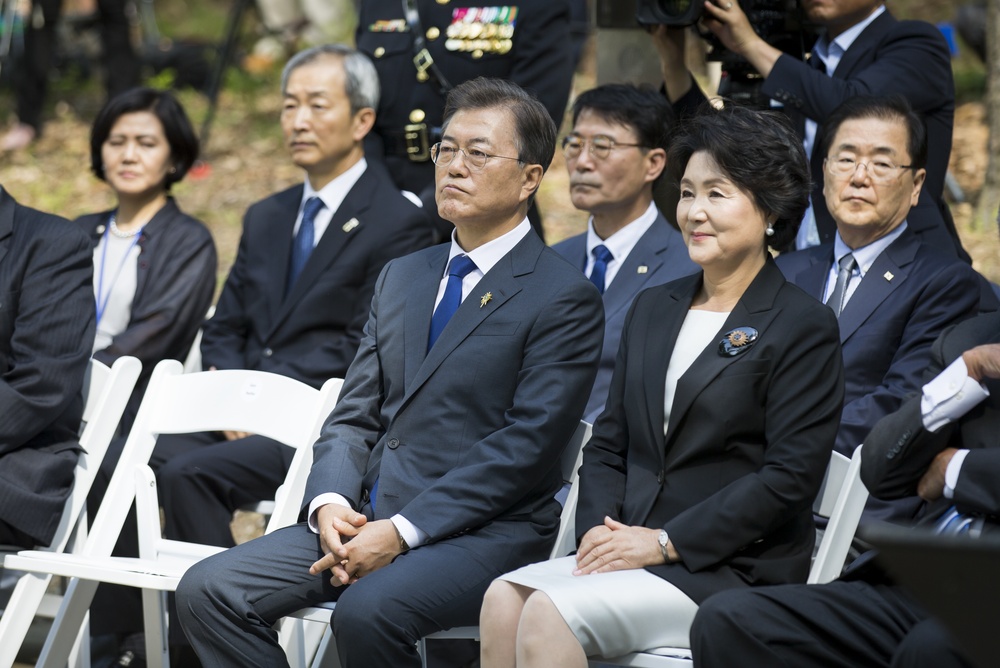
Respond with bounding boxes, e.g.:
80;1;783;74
90;88;198;190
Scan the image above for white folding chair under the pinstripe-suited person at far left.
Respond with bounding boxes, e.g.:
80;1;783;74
0;357;142;666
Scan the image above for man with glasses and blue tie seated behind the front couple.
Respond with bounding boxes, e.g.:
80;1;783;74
553;84;698;423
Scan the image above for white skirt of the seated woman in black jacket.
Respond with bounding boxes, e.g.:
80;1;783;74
500;557;698;657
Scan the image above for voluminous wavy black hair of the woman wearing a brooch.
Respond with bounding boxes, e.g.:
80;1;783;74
667;101;810;248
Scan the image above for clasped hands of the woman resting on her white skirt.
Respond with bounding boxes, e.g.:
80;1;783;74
573;517;680;575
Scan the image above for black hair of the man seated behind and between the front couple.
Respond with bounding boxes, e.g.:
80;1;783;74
573;83;674;150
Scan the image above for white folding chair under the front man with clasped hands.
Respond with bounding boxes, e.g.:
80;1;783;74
282;422;591;667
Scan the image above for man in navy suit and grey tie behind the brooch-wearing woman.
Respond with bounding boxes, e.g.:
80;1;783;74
778;97;979;519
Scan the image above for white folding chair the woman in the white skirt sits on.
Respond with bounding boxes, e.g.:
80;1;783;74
590;446;868;668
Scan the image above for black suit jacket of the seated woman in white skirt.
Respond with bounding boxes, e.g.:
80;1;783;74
576;261;844;603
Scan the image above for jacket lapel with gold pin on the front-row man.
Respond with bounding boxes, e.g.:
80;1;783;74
403;233;544;405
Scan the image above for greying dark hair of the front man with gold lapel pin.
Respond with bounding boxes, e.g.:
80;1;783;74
442;77;556;172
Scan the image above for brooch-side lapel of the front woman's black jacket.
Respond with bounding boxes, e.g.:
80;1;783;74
659;259;785;459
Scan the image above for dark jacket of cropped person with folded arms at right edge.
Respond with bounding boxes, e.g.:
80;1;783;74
861;313;1000;525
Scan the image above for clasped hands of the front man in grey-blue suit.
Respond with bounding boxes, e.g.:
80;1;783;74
309;503;400;587
